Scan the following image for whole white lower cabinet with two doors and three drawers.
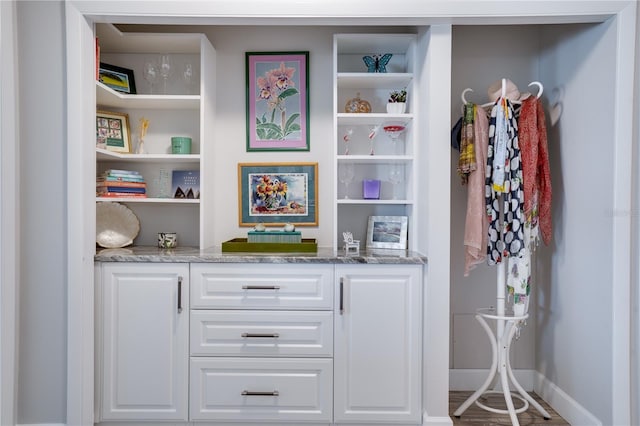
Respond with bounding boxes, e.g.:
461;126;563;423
96;262;422;425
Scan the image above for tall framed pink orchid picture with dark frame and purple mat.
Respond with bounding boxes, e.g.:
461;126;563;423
245;52;309;151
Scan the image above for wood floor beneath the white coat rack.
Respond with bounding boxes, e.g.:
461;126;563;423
449;391;569;426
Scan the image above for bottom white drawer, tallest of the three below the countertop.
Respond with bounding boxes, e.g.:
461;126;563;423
190;358;333;422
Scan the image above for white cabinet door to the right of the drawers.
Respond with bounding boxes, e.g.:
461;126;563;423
334;265;422;424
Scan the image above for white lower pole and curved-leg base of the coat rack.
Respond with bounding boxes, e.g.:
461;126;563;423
453;262;551;426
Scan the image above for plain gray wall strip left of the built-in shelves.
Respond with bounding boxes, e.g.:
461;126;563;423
17;1;67;424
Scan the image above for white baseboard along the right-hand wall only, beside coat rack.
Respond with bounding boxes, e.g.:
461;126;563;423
535;372;602;426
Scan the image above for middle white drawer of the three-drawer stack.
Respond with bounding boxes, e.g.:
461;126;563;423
190;310;333;357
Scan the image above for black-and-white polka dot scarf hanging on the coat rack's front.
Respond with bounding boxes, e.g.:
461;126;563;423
485;98;524;265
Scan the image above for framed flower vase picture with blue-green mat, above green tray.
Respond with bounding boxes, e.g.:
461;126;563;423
238;163;318;226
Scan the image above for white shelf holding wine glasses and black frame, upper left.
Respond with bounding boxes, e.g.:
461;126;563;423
96;81;200;110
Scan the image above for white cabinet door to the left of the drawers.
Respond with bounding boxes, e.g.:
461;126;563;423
98;263;189;421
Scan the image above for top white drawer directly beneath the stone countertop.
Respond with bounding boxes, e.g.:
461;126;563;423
191;264;333;310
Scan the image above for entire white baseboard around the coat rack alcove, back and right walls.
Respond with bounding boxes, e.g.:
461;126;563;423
449;369;602;426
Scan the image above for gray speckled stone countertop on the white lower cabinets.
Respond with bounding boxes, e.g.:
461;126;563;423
94;246;427;265
